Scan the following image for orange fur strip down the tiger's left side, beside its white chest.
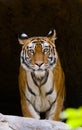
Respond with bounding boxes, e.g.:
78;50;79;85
19;66;33;117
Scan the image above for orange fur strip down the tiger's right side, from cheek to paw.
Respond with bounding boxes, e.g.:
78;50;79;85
53;60;65;120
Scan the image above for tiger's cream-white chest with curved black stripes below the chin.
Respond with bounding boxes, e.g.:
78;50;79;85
25;71;57;119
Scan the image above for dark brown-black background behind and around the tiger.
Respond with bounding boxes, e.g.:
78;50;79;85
0;0;82;115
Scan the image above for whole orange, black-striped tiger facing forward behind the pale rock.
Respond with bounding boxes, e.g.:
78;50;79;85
18;30;65;120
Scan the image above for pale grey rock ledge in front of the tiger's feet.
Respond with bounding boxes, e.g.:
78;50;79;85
0;114;69;130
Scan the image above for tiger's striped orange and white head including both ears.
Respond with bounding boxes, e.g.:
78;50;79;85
18;30;58;72
